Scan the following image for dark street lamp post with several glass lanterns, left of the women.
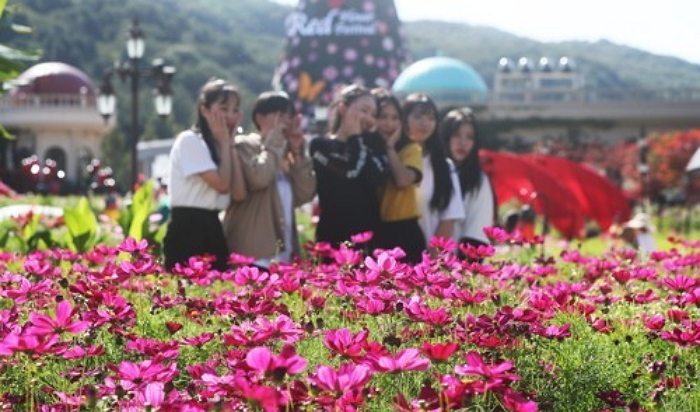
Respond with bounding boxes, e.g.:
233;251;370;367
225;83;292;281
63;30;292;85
97;19;175;189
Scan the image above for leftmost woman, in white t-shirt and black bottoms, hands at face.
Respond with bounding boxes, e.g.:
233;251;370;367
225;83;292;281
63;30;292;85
163;79;246;270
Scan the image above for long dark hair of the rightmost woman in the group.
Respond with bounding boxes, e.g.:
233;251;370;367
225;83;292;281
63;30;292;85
439;108;481;195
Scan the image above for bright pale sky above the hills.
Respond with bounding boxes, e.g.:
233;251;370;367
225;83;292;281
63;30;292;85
273;0;700;64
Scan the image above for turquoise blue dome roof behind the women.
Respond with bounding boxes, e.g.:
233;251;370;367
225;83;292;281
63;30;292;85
392;56;488;108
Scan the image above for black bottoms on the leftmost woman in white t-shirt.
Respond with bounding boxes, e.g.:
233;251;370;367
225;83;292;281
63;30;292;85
163;207;229;270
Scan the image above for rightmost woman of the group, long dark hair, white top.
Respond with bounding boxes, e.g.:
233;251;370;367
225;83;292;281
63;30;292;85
440;108;496;246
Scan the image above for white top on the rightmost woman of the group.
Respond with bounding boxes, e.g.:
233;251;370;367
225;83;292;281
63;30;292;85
453;172;494;244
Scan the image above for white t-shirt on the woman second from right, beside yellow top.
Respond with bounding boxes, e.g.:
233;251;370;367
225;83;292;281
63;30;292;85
418;156;464;244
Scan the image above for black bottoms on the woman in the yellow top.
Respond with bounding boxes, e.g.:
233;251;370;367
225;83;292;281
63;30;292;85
375;219;427;263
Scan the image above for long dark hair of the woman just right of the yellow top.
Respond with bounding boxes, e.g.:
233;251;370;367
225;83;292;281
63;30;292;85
401;93;455;211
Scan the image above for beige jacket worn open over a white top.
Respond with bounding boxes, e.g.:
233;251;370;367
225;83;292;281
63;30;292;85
224;133;316;259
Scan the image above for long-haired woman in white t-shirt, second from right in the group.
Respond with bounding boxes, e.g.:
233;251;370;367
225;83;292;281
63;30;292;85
402;93;464;251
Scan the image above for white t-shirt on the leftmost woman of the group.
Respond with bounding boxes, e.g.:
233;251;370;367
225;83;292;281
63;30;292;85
169;130;229;210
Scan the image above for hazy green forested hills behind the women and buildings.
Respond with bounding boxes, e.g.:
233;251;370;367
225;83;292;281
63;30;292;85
0;0;700;185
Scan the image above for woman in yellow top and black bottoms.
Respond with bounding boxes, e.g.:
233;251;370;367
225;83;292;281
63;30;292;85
372;89;426;263
